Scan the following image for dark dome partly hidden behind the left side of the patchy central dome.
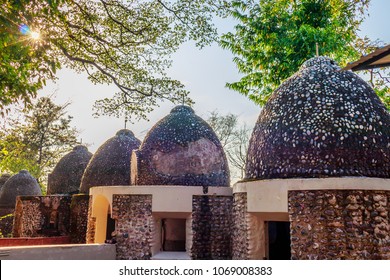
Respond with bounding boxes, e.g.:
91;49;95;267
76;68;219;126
80;129;141;193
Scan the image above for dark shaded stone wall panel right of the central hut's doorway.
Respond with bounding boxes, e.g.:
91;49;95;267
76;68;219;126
189;195;233;260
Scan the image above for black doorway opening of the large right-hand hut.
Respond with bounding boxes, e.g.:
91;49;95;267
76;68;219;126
266;221;291;260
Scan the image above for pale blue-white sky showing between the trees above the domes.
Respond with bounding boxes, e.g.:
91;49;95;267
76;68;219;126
39;0;390;152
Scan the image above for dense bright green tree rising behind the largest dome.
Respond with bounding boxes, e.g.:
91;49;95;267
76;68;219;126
221;0;370;105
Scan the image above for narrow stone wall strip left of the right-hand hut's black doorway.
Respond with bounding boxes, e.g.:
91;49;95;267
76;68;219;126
232;193;249;260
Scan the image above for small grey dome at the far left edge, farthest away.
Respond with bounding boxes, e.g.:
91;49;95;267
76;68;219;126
0;170;42;208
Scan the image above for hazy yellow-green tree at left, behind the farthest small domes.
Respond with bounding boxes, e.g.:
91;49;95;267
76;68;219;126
0;97;78;186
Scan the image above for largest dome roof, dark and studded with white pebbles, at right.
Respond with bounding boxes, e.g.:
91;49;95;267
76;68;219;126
245;57;390;180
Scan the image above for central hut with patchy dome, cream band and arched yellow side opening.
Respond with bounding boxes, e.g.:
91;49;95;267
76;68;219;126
87;106;232;259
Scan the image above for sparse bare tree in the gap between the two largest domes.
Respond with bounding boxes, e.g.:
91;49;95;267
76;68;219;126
207;111;252;182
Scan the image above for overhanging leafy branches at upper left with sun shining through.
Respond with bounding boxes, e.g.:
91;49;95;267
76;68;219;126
0;0;229;118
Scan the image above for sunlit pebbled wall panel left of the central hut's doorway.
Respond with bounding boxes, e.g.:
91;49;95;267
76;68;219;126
112;195;154;260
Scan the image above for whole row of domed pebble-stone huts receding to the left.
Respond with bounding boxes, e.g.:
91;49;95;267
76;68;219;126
0;57;390;259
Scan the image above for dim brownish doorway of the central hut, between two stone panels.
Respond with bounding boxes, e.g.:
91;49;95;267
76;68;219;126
161;219;186;252
